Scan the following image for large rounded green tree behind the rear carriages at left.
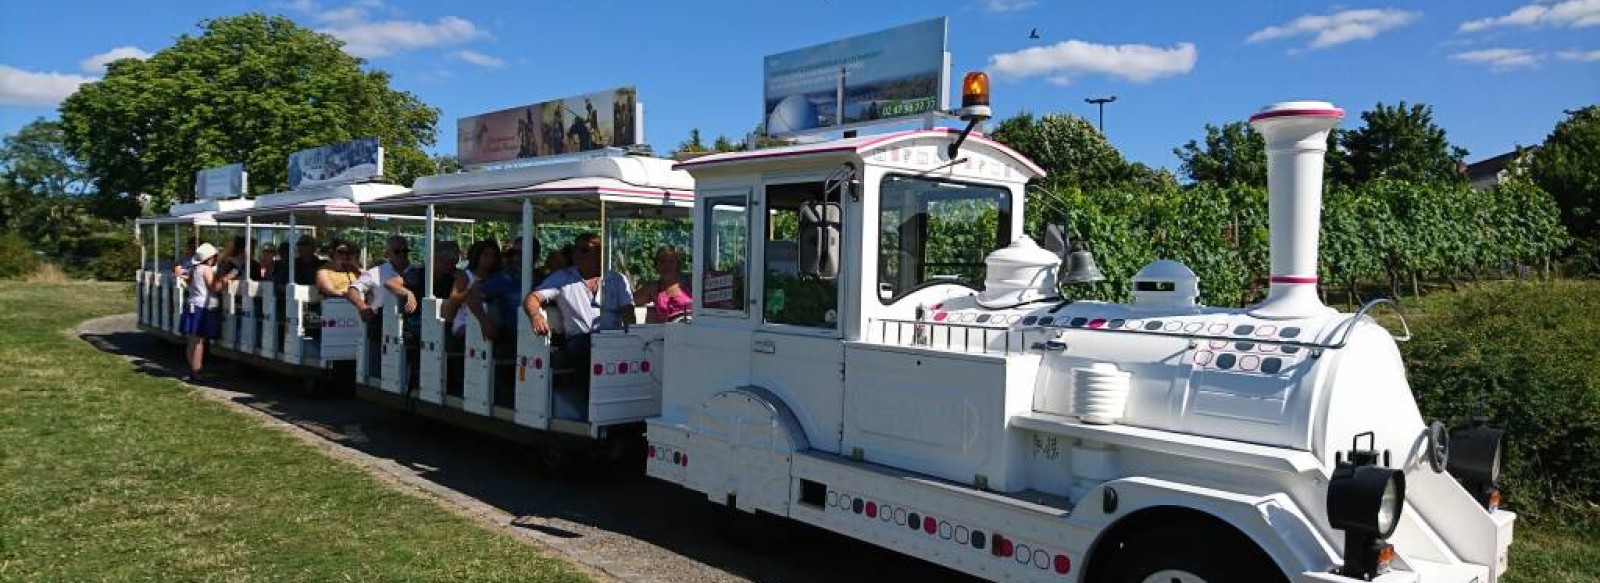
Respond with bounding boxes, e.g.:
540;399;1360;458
61;13;438;213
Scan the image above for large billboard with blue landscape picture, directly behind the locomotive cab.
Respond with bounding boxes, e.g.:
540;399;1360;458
762;18;949;136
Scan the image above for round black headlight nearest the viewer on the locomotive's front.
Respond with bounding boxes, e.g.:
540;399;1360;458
1328;464;1405;538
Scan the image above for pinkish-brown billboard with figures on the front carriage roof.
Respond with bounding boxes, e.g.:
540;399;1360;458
456;86;645;165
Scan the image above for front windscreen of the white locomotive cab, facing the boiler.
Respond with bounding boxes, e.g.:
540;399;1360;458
878;175;1011;304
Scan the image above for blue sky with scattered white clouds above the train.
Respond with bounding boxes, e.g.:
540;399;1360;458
0;0;1600;168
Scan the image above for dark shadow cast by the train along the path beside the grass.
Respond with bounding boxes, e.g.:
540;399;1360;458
80;317;976;583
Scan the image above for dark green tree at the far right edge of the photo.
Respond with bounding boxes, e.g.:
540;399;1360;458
1528;106;1600;272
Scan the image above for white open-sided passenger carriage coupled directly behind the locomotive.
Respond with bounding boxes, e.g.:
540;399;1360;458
358;151;694;456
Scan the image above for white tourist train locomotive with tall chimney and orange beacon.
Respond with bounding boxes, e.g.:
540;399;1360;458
646;87;1515;581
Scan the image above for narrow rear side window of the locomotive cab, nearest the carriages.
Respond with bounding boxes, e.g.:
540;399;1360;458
694;195;750;312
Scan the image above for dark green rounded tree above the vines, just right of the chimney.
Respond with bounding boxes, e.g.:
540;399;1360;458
1339;101;1467;184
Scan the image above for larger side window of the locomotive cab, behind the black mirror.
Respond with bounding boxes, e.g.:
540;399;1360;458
762;183;843;328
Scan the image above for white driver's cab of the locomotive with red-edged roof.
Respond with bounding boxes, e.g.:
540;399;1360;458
662;130;1042;453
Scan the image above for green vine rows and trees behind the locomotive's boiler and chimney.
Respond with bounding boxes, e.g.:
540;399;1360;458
992;103;1580;306
